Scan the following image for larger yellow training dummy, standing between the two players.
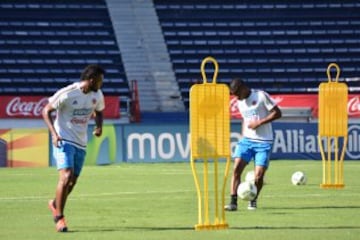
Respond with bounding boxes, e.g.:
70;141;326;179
190;57;230;230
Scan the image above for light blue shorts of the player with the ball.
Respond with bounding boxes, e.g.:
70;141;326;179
233;138;272;168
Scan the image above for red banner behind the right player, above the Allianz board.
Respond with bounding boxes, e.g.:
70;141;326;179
230;94;360;119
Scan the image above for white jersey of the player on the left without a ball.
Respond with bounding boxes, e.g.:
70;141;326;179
49;82;105;148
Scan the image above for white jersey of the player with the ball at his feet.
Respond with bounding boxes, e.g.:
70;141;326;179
237;89;276;141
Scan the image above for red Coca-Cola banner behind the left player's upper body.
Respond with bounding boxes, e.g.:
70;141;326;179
0;96;120;119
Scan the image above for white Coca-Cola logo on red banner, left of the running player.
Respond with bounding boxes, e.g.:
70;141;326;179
6;97;48;117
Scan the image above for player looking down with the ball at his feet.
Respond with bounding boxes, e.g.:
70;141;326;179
225;78;281;211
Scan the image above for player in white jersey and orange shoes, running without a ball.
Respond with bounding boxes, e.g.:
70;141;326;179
42;65;105;232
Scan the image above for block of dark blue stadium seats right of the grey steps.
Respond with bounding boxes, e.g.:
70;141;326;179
154;0;360;105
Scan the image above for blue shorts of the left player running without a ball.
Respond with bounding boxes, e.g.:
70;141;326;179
53;141;86;176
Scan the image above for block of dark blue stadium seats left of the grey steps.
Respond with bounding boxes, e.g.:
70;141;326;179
0;0;130;100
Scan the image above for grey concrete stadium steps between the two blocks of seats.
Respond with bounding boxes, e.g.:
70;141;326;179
107;0;185;112
